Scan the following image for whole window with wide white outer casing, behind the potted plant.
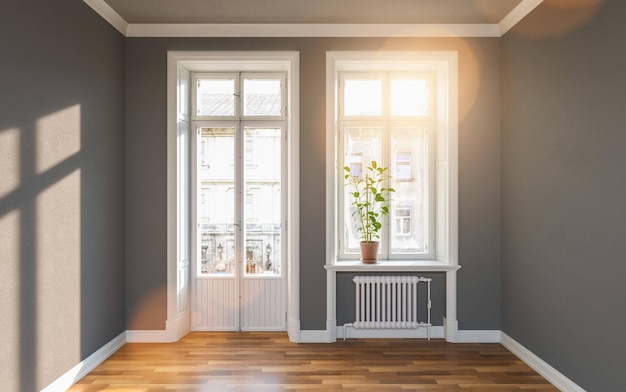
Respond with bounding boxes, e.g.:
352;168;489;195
327;52;458;264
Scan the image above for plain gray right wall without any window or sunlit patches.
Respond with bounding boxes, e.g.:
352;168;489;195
502;0;626;392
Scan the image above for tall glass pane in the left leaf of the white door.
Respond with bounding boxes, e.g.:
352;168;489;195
197;128;235;275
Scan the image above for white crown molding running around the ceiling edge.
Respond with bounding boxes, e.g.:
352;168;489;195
83;0;543;37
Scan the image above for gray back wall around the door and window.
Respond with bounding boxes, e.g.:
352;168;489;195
126;38;501;330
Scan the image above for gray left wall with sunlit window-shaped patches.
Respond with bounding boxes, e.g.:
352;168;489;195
0;0;125;392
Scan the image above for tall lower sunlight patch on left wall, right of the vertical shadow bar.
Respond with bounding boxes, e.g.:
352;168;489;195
34;169;81;377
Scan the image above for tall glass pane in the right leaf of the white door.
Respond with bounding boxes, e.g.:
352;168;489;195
243;127;282;276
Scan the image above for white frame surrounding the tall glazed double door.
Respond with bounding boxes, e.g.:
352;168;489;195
165;51;300;342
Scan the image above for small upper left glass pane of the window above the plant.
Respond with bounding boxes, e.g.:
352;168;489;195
344;79;383;116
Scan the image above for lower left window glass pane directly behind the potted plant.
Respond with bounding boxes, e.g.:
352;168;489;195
342;127;382;254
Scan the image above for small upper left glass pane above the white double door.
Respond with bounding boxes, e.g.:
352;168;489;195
196;79;235;116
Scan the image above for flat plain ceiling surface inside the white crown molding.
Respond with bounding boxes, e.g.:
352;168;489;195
105;0;521;23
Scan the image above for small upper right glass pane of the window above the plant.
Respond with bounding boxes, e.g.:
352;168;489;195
390;79;428;116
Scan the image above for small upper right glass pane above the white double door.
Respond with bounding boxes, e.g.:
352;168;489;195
243;79;282;116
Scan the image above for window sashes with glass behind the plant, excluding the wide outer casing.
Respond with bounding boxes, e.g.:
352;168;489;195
337;70;435;259
